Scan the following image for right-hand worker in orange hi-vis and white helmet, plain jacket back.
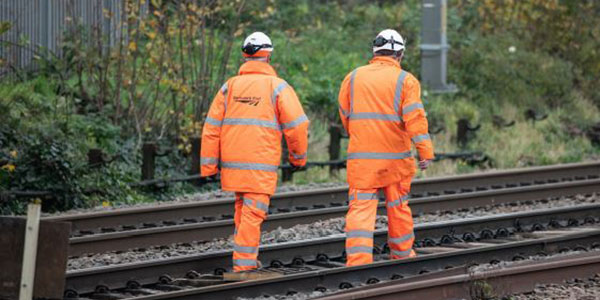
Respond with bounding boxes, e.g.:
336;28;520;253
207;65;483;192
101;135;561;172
338;29;434;266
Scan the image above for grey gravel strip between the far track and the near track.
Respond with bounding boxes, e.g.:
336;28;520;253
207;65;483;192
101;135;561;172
67;194;600;270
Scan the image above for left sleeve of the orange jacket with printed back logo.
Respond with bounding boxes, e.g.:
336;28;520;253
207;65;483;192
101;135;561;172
200;83;227;176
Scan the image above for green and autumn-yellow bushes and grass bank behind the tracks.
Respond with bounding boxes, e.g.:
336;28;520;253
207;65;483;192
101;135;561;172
0;0;600;213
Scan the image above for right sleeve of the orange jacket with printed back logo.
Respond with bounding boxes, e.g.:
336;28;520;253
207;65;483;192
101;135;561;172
275;82;309;166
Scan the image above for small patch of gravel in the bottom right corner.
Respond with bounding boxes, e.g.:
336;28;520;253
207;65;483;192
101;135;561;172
505;273;600;300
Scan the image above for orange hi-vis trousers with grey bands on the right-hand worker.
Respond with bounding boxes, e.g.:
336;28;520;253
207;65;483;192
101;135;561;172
346;178;416;266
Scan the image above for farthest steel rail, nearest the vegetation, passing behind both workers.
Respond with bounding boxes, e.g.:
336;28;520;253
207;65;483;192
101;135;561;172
44;162;600;231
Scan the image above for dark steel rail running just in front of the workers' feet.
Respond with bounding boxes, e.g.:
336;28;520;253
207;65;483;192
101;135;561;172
122;227;600;300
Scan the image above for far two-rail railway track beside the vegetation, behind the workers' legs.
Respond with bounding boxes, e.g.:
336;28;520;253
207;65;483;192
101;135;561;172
52;162;600;256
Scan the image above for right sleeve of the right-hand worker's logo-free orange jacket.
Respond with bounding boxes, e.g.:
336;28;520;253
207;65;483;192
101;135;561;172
402;76;434;160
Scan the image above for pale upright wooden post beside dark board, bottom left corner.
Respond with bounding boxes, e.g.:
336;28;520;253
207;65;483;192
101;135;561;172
19;199;41;300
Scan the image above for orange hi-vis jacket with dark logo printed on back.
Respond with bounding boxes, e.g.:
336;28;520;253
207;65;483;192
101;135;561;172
200;61;309;195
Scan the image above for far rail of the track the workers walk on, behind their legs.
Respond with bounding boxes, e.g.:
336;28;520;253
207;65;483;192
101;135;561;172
66;204;600;293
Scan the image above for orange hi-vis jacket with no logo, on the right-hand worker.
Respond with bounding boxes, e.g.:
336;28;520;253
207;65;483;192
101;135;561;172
338;56;433;189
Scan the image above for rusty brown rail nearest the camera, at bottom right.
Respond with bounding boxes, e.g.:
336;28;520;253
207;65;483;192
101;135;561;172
316;253;600;300
